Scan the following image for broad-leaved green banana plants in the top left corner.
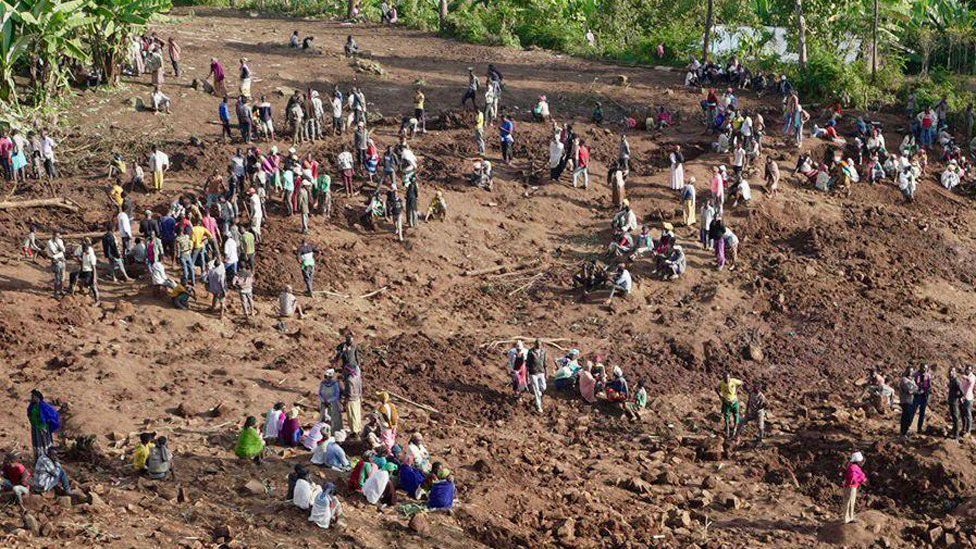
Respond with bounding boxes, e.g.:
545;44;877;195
0;0;170;104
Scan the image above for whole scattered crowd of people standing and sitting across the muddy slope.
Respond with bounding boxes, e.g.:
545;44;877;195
7;8;976;528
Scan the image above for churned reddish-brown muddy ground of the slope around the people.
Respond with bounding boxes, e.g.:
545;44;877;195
0;10;976;547
